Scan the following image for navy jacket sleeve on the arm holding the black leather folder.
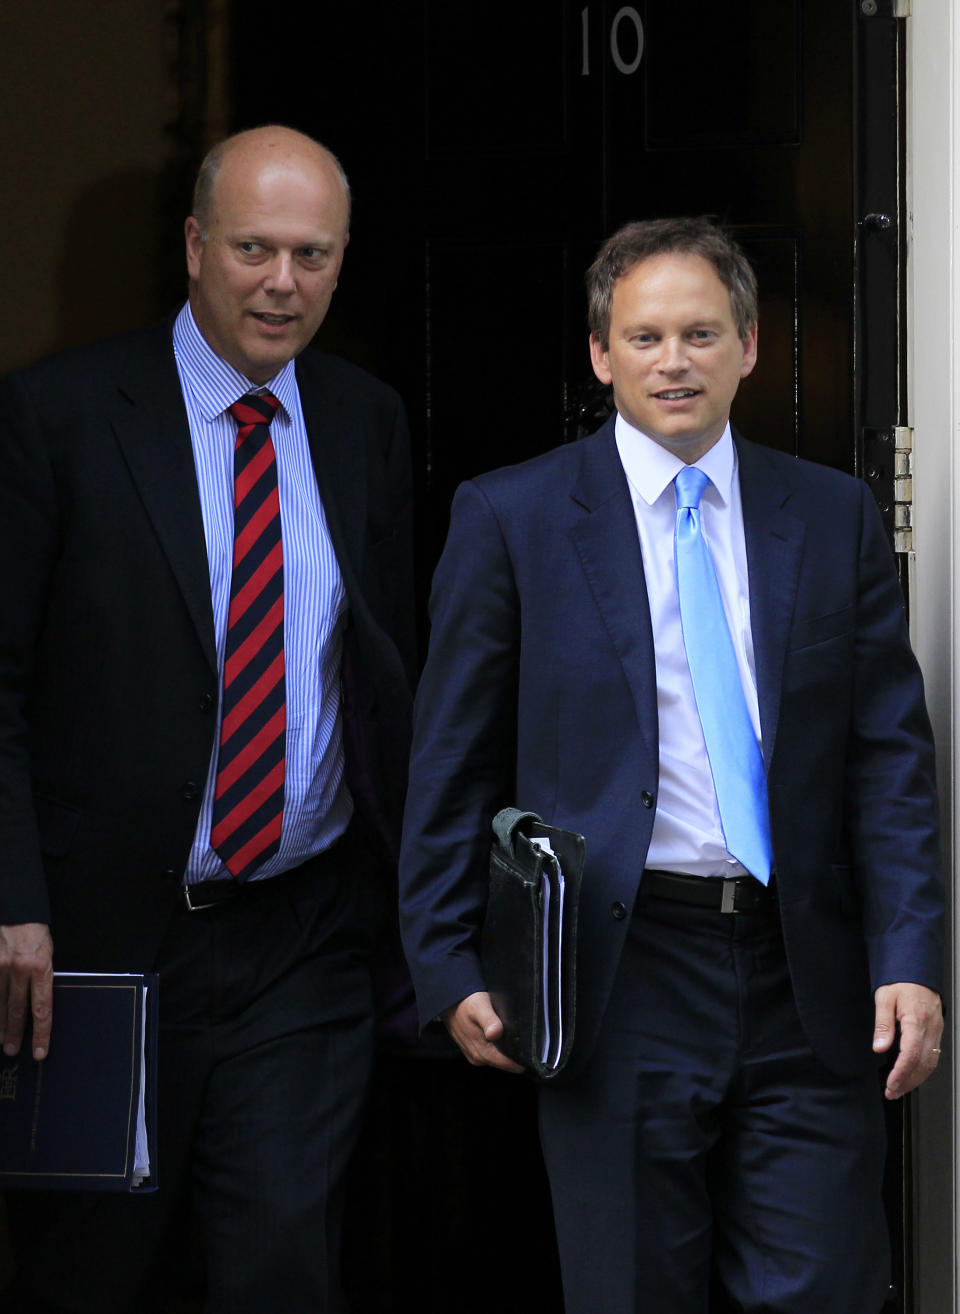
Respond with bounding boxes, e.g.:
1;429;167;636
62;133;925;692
401;484;520;1025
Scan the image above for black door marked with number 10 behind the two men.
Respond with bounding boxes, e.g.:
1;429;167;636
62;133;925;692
234;0;902;1314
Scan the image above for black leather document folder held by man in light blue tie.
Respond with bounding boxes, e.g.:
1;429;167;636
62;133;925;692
481;808;584;1081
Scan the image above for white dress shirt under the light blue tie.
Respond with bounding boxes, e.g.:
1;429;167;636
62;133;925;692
616;415;760;876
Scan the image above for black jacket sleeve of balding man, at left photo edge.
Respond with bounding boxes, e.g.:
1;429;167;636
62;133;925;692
0;377;56;925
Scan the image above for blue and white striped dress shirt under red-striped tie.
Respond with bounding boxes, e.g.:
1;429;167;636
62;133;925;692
173;302;353;884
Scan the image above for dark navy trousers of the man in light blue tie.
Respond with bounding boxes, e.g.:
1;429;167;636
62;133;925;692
540;884;889;1314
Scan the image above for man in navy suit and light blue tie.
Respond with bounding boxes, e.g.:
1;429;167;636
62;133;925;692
401;219;942;1314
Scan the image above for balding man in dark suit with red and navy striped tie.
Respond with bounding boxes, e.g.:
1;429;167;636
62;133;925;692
0;127;414;1314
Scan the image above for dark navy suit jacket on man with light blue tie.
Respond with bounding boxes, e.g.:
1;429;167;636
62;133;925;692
401;420;943;1074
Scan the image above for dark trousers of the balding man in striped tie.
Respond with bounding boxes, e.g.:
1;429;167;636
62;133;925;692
0;846;373;1314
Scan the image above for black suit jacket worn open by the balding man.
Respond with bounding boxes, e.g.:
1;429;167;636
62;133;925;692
0;322;414;971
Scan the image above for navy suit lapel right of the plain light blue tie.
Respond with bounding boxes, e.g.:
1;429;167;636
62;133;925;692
735;435;805;767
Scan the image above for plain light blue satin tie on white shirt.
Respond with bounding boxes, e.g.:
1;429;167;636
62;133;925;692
674;465;772;886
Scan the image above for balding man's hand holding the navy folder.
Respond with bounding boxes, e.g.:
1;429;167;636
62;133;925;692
0;921;54;1059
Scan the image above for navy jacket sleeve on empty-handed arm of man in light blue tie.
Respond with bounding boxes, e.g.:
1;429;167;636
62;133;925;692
846;487;943;991
